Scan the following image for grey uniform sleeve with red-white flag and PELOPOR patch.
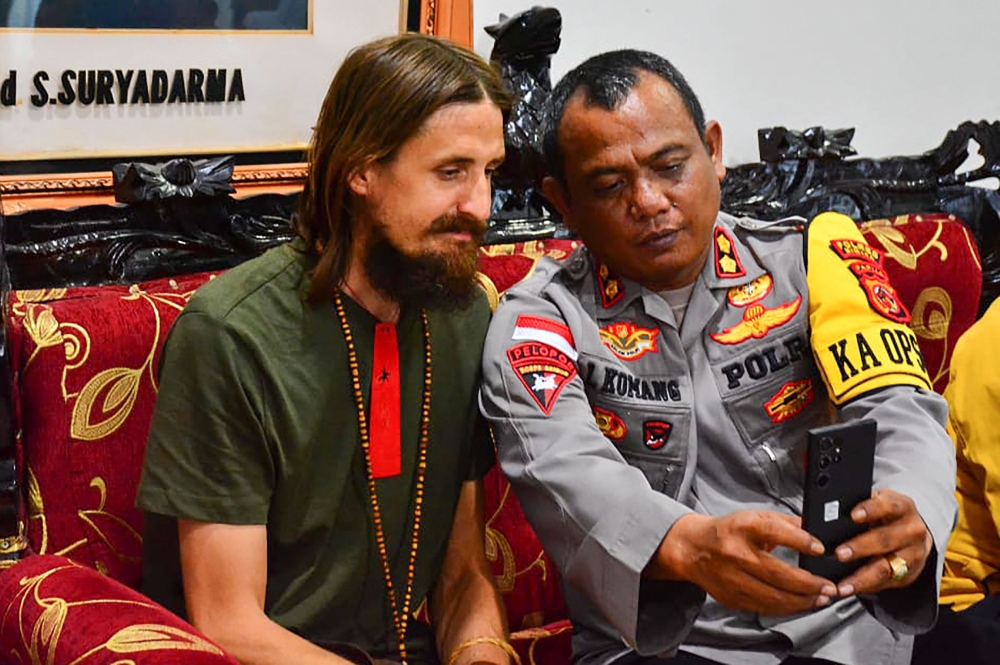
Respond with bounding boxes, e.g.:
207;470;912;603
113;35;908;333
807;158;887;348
480;291;705;655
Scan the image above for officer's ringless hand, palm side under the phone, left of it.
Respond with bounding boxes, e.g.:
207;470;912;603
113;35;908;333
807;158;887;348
647;510;837;616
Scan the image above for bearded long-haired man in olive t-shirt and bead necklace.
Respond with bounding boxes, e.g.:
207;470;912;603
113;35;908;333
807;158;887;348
139;35;511;665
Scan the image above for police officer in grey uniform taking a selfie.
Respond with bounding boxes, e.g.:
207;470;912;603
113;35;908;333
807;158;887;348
481;51;955;665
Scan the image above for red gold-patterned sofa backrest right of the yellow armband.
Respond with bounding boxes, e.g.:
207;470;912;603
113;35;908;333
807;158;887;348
861;214;983;393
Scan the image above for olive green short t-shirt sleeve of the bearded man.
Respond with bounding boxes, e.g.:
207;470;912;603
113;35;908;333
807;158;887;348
137;312;274;524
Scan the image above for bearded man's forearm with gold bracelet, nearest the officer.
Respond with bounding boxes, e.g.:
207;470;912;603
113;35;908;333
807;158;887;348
430;570;510;665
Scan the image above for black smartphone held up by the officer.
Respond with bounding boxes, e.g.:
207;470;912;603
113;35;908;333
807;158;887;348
799;418;878;582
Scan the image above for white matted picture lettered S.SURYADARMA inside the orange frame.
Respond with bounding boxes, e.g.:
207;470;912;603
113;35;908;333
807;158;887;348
0;0;412;161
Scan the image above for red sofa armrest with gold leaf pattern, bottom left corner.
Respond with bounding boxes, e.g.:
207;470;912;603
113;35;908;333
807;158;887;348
0;555;237;665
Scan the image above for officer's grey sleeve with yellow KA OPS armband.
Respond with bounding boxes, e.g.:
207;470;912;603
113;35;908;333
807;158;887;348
806;213;957;633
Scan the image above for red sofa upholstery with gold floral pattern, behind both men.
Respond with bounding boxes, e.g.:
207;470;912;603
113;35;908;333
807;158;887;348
0;206;981;665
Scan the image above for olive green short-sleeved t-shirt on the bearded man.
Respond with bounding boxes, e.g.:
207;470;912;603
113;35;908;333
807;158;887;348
137;243;494;655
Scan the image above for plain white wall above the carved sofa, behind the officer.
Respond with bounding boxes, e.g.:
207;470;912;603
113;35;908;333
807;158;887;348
474;0;1000;165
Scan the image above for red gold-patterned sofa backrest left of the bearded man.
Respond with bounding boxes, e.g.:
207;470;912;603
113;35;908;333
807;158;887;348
8;273;218;587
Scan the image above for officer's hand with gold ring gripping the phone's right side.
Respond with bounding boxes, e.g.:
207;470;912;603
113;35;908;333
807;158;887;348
834;489;934;596
